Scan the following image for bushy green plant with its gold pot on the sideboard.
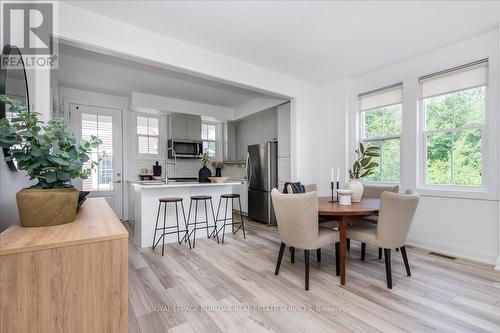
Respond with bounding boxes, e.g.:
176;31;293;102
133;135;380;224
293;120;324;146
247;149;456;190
0;95;101;227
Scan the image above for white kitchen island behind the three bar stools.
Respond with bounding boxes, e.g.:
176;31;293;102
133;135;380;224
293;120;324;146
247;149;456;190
132;181;242;247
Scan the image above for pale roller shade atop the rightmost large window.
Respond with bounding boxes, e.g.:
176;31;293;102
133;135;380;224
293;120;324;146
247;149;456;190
419;60;488;98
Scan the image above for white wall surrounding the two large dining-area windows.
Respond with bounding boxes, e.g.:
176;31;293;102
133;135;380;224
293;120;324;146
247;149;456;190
349;30;499;264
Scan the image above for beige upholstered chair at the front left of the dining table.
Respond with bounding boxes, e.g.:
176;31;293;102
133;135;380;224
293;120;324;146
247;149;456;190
271;189;339;290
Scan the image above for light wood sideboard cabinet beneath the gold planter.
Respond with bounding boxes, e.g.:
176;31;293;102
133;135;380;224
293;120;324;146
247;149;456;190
0;198;128;333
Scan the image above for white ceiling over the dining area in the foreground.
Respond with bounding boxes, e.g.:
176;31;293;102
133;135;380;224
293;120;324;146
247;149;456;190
67;1;499;84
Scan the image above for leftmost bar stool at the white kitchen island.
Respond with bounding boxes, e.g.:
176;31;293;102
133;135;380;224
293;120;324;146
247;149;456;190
153;197;191;256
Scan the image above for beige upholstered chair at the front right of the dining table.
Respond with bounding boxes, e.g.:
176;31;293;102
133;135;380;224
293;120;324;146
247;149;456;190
346;190;420;289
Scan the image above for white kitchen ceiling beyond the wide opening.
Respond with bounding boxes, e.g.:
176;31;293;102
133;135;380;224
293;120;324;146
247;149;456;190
57;44;280;108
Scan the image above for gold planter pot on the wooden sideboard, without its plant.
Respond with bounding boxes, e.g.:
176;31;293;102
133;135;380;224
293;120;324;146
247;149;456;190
16;187;78;227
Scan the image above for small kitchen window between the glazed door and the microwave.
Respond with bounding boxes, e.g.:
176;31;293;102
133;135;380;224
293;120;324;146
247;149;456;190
137;116;160;155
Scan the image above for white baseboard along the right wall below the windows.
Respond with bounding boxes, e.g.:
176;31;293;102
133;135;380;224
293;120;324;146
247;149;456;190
406;235;500;264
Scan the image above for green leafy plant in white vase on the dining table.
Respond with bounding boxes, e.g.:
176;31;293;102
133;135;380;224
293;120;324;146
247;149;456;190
349;142;380;202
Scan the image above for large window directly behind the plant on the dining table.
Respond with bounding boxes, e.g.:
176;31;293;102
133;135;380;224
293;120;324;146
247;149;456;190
358;84;403;183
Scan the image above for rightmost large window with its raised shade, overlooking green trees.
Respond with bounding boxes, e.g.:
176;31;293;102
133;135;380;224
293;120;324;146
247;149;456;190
419;59;488;187
